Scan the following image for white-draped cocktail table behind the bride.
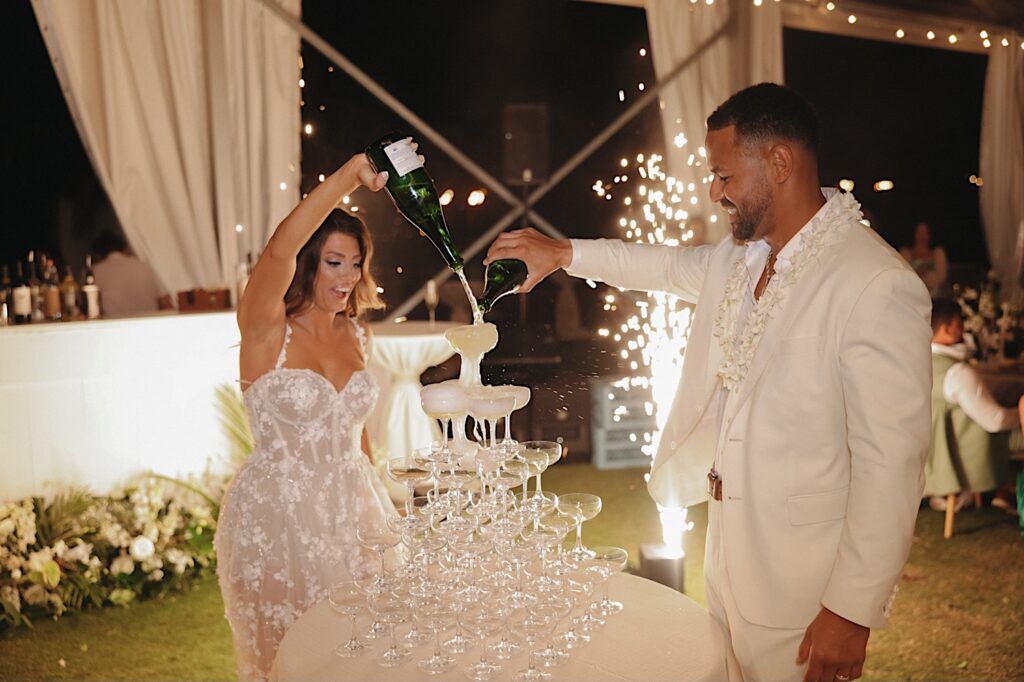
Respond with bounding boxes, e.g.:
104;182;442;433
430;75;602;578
367;322;458;462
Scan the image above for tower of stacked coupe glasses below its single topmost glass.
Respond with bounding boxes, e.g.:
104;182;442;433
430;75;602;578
330;382;628;680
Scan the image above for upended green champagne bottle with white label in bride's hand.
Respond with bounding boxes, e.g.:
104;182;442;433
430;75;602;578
367;132;463;272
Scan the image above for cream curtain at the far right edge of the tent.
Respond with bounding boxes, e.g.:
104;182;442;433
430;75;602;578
979;36;1024;298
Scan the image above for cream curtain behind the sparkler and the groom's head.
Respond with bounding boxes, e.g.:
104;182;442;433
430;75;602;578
644;0;782;242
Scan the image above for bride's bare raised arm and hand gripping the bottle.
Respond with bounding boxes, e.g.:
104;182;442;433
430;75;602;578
238;154;387;343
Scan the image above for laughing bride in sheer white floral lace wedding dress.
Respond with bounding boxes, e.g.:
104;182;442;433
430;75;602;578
216;154;394;680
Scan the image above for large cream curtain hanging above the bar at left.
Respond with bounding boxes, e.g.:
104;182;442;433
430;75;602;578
33;0;301;292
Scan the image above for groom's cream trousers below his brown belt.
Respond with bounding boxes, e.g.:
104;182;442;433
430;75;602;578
705;493;810;682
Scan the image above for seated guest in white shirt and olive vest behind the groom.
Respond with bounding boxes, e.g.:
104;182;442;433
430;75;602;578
924;299;1024;511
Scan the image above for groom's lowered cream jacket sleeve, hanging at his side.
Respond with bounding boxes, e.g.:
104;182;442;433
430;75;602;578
821;268;932;628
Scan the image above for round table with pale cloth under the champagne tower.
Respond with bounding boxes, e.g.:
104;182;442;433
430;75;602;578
270;574;728;682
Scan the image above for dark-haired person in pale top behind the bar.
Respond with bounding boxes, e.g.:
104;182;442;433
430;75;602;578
91;229;172;317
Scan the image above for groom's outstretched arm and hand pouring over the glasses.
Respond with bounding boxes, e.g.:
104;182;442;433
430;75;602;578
483;227;714;302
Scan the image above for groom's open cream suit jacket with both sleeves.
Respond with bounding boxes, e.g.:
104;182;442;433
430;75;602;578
569;188;932;628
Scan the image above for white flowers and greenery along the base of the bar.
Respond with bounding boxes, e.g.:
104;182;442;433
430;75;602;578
0;387;252;631
